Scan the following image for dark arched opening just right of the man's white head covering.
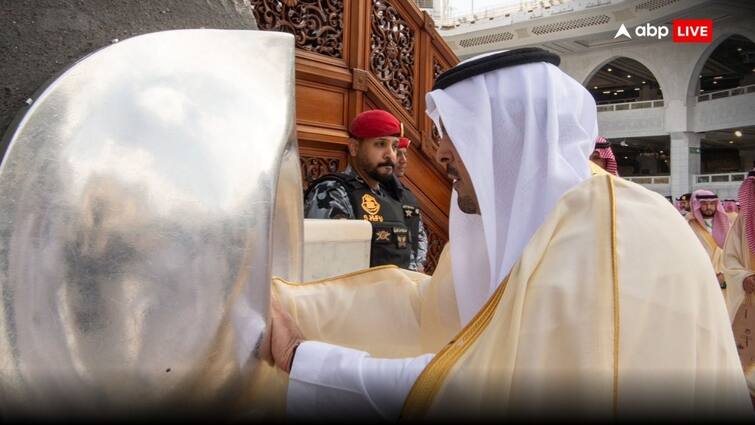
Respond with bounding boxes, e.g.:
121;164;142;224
585;57;663;105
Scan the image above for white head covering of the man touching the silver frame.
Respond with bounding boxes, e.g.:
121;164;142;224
426;57;598;324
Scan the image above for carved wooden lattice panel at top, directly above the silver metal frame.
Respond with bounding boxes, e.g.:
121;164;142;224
251;0;343;58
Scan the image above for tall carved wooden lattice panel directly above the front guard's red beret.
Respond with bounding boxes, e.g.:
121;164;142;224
370;0;415;112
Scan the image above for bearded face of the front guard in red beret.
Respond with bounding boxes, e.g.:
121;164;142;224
349;136;398;183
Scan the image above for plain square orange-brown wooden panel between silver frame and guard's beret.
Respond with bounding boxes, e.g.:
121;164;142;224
296;81;348;130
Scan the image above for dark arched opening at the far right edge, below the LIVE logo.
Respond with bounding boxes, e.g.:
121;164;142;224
696;35;755;95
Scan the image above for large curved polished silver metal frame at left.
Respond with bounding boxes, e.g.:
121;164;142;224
0;30;302;414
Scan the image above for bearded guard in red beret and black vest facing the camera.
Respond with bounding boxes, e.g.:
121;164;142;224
304;110;419;269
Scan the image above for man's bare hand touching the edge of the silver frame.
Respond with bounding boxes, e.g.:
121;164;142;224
260;297;304;373
